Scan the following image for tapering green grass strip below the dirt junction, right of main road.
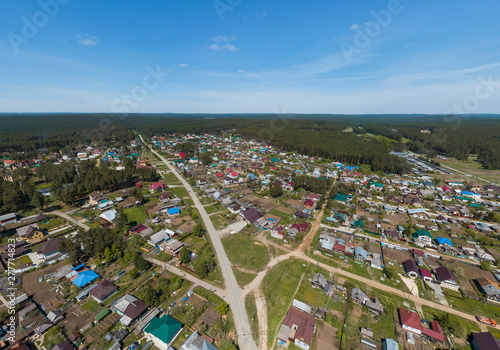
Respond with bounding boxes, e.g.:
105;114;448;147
262;259;306;345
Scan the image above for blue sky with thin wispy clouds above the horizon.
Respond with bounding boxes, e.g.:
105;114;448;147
0;0;500;114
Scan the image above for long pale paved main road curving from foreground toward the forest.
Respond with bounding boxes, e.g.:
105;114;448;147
139;135;257;350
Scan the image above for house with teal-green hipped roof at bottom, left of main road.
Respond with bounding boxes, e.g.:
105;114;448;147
144;315;182;350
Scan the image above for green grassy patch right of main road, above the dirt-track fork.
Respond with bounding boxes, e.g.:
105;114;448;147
222;233;269;270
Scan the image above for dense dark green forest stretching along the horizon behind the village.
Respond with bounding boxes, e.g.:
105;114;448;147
0;114;500;173
